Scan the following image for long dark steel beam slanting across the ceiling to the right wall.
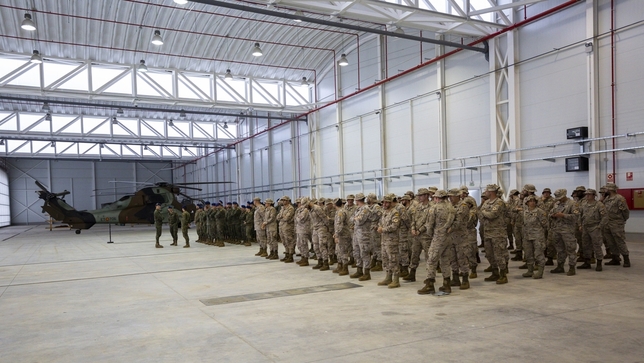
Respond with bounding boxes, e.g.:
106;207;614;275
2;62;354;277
190;0;488;54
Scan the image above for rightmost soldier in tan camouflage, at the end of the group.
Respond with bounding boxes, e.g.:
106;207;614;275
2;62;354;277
604;183;631;267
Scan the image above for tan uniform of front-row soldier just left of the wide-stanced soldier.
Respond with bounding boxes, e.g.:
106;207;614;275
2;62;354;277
378;198;400;275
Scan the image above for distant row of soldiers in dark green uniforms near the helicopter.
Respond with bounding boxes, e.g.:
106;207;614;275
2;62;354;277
194;202;254;247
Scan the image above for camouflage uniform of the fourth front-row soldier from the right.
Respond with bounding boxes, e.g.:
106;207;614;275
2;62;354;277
521;198;548;268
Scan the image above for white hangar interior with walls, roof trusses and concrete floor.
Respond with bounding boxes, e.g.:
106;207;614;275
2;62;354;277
0;0;644;362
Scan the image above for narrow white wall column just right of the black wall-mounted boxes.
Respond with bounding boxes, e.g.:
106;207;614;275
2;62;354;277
585;0;608;190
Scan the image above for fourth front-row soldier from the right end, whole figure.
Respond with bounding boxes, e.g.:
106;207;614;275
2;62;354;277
521;195;548;279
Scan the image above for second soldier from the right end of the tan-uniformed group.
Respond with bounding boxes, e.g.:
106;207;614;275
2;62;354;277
577;188;608;271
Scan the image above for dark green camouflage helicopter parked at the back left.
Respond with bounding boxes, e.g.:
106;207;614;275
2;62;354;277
36;181;230;234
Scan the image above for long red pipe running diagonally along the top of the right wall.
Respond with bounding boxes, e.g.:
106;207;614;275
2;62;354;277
179;0;580;168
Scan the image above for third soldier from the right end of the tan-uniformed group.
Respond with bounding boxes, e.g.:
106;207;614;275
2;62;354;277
549;189;579;276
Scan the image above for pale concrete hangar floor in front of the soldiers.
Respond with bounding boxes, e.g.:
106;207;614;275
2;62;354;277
0;226;644;363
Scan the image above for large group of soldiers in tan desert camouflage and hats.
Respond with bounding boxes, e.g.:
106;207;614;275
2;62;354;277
247;183;630;294
